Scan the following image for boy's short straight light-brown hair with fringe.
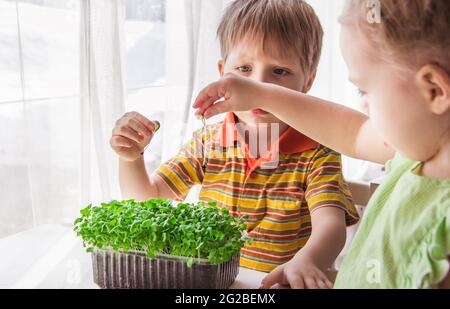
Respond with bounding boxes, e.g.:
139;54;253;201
217;0;323;74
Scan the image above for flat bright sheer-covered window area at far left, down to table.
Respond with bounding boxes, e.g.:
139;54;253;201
0;0;80;237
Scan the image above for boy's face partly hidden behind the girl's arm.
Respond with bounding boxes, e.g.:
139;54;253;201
219;41;314;129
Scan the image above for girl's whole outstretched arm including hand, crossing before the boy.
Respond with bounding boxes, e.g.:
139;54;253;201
194;74;394;164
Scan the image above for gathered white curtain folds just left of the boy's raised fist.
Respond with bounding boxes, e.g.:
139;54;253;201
80;0;126;205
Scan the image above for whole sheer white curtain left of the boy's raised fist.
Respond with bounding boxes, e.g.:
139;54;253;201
0;0;125;238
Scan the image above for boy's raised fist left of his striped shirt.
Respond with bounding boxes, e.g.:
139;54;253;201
110;112;160;161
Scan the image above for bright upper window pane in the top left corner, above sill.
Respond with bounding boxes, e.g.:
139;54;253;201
0;0;80;102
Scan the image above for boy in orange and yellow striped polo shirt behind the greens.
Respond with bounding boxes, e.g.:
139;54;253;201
111;0;358;288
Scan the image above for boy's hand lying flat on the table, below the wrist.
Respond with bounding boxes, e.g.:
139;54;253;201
261;256;333;289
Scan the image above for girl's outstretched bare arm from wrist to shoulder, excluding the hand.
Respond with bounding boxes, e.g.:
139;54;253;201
262;87;394;164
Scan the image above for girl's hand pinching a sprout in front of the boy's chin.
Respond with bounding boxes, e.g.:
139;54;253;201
193;73;264;119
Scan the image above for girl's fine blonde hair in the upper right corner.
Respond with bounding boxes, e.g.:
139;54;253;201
340;0;450;72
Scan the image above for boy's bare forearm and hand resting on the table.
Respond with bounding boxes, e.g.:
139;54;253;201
261;207;346;289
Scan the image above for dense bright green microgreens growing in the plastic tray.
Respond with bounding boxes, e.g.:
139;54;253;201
74;199;247;266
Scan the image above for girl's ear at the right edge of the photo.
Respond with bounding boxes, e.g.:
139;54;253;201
416;64;450;115
